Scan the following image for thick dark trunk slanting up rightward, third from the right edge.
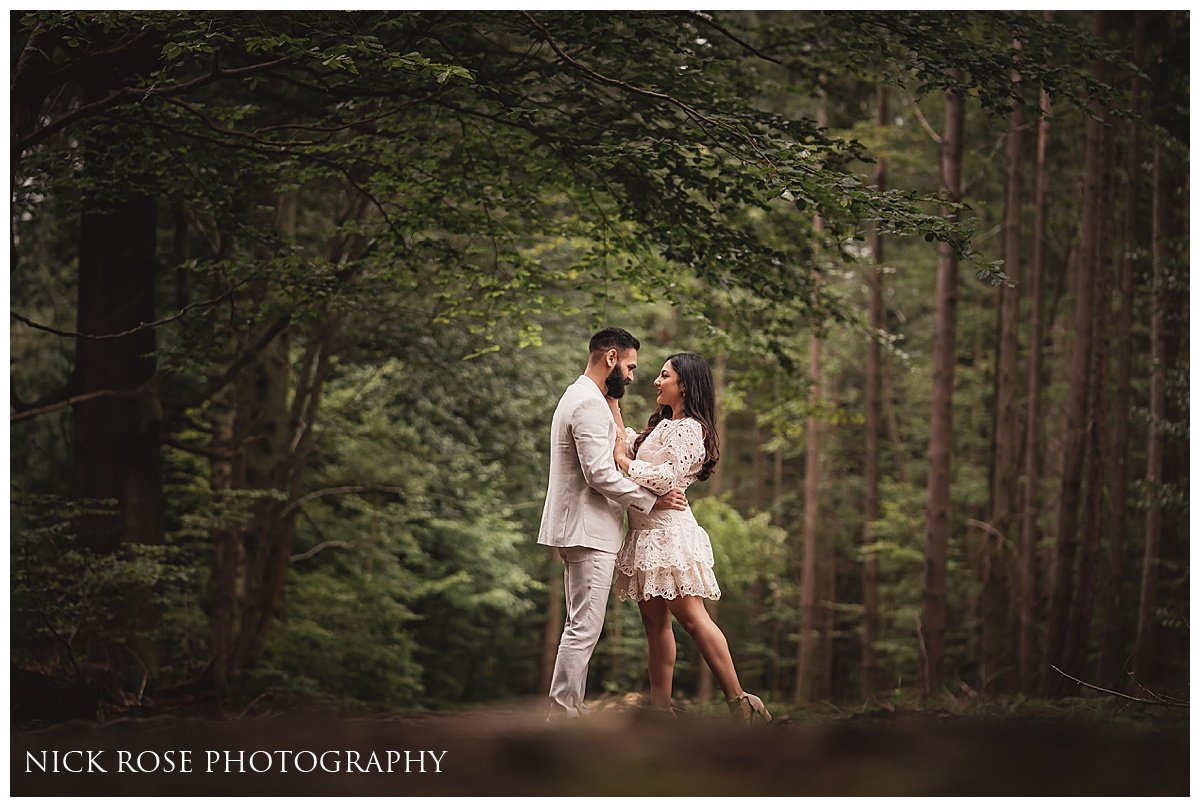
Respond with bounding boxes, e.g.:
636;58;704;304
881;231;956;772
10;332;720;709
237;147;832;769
1040;12;1106;695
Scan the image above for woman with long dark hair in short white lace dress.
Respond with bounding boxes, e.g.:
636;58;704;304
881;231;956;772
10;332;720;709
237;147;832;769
610;353;772;723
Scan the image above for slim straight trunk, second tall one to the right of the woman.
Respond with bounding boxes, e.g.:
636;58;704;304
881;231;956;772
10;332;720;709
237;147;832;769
859;84;888;699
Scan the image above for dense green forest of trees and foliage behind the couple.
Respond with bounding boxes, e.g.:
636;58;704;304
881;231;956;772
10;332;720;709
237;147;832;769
8;11;1190;739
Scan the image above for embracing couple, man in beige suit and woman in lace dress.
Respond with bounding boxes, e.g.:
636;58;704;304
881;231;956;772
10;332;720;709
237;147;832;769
538;328;770;722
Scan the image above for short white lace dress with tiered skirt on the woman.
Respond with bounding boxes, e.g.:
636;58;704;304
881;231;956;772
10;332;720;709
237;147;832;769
617;418;721;599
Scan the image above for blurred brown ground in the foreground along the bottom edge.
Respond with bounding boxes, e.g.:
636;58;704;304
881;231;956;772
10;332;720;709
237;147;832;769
10;701;1188;796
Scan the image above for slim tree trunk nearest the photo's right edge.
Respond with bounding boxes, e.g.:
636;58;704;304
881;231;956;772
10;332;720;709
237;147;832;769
1133;142;1166;677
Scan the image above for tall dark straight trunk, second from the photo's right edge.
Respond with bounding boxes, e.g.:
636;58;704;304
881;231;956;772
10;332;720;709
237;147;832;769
1097;11;1146;688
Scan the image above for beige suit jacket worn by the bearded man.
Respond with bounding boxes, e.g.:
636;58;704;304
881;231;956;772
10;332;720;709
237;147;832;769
538;376;658;552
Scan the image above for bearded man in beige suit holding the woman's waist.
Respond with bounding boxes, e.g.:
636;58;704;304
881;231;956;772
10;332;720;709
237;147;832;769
538;328;688;718
